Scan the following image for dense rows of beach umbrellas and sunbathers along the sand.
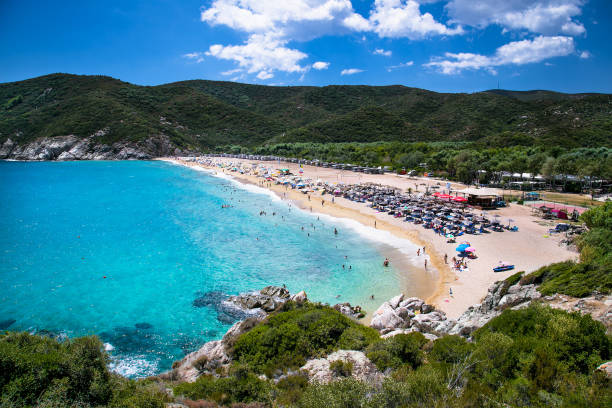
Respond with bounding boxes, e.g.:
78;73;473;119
181;157;518;271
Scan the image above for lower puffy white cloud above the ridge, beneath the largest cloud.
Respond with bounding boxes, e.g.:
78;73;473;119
206;34;307;75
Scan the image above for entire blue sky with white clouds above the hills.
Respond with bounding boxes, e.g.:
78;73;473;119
0;0;612;93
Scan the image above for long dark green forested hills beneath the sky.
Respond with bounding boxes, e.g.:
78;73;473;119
0;74;612;149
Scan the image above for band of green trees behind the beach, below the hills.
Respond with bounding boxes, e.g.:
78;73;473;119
218;142;612;186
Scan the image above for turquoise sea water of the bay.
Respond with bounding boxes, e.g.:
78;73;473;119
0;162;408;376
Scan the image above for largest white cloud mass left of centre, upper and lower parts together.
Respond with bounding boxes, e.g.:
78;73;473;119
201;0;370;79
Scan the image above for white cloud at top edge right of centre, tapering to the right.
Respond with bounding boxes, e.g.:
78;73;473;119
370;0;463;40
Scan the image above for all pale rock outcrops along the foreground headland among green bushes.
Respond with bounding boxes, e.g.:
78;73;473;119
162;280;612;383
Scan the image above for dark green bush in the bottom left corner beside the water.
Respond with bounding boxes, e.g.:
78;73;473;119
0;333;164;408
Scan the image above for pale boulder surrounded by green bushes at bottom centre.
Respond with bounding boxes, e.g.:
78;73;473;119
300;350;383;384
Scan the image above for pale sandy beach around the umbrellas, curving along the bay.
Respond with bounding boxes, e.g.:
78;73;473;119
161;158;578;318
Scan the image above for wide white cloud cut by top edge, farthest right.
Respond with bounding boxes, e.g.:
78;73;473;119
446;0;585;36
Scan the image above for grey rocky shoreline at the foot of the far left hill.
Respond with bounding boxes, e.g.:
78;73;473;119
0;133;190;161
